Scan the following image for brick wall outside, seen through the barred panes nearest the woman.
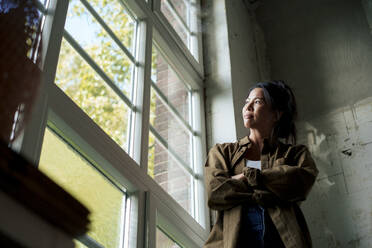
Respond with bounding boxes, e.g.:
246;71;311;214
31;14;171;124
154;50;192;212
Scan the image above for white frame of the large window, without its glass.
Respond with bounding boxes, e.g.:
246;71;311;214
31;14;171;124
18;0;209;247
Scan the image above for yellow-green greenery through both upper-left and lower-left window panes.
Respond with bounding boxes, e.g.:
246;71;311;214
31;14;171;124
48;0;142;247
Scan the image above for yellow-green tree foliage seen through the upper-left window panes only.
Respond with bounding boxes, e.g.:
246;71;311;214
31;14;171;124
55;0;135;149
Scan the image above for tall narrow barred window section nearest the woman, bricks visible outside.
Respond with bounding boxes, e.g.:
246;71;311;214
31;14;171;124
148;46;194;215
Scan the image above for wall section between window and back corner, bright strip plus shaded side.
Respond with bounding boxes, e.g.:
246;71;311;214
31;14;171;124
203;0;269;148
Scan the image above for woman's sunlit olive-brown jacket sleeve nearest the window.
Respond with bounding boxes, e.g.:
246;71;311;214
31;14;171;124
204;145;253;210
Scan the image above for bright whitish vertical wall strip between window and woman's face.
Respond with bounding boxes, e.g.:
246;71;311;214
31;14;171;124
203;0;236;148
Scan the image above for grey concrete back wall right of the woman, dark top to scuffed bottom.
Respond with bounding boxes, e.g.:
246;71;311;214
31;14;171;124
256;0;372;247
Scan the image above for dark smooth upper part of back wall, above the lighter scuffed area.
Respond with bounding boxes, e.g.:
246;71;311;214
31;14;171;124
256;0;372;119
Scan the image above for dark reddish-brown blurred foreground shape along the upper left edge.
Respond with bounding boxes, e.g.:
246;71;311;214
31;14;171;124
0;0;41;143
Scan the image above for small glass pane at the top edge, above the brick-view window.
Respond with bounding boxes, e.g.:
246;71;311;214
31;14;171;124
160;0;189;47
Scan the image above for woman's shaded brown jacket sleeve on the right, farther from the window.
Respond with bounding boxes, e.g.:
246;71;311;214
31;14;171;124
261;145;318;202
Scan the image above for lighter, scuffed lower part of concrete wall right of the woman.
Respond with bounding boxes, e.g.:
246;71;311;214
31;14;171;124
299;97;372;247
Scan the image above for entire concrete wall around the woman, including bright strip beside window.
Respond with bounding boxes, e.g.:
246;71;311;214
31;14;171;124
205;0;372;247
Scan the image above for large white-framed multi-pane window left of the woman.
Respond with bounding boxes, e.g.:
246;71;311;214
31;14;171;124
20;0;209;248
